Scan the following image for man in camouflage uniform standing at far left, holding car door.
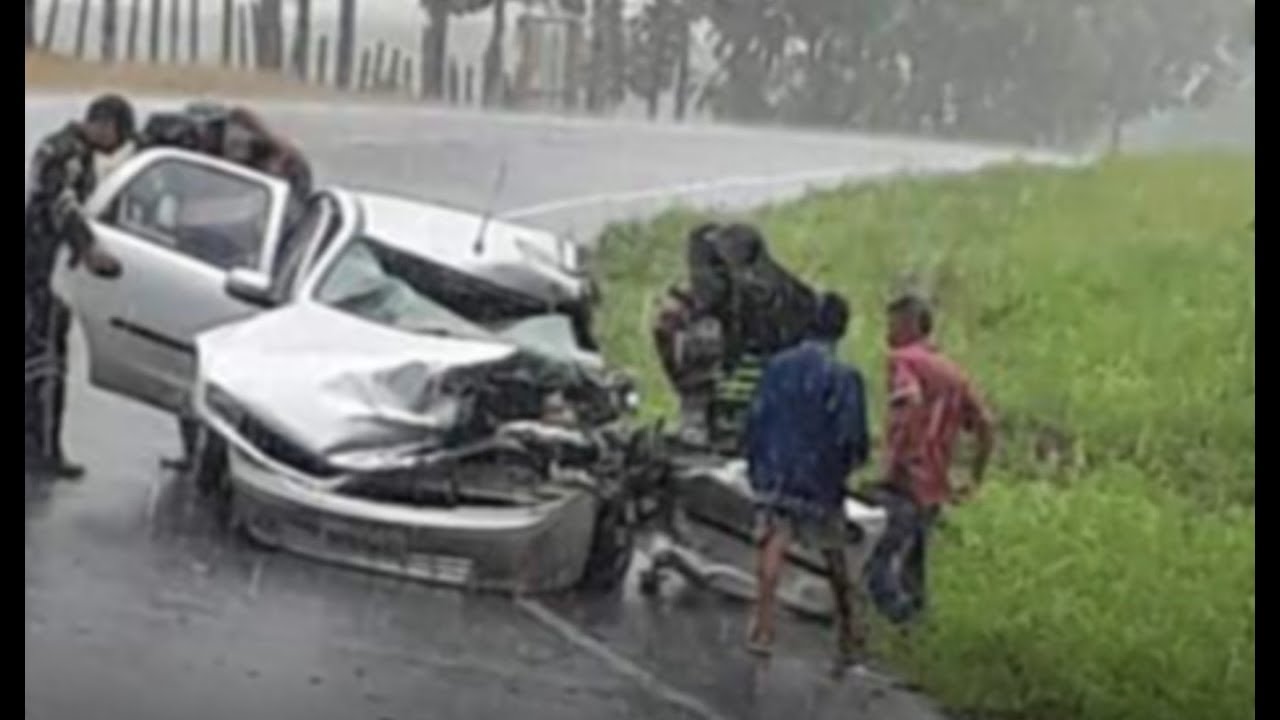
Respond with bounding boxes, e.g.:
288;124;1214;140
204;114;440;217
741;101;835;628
23;95;133;479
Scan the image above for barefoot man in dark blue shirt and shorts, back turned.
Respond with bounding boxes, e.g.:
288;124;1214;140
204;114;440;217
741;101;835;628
746;293;870;665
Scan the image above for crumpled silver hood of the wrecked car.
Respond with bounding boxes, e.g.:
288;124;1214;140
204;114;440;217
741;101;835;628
196;304;517;465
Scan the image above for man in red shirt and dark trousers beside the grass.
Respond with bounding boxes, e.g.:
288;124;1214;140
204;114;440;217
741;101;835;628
868;295;993;623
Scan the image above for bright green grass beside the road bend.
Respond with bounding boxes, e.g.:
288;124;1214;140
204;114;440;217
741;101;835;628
599;155;1254;720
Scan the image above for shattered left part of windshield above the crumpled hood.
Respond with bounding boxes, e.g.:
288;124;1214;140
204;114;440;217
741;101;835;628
316;237;493;338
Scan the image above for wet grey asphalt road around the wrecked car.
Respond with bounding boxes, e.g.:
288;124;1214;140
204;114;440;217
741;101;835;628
24;99;1034;720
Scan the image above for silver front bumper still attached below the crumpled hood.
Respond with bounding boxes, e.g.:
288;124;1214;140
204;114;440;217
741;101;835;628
222;441;598;593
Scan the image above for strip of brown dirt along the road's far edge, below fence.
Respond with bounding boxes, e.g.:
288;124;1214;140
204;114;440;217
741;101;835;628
27;53;402;101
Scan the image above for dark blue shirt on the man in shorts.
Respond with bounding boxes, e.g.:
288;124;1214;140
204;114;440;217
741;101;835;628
746;342;870;518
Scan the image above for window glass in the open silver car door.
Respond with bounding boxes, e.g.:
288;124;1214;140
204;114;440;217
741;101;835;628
104;159;271;270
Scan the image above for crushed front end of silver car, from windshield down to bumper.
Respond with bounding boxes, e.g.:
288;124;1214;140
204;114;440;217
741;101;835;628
195;233;645;592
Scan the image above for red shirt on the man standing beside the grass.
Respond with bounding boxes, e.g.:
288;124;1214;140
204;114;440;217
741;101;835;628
886;341;987;507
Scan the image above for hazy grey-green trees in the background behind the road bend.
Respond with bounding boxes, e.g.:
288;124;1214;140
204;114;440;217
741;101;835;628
421;0;1253;145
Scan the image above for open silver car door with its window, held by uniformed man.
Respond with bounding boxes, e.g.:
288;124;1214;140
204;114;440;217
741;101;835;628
63;150;291;413
